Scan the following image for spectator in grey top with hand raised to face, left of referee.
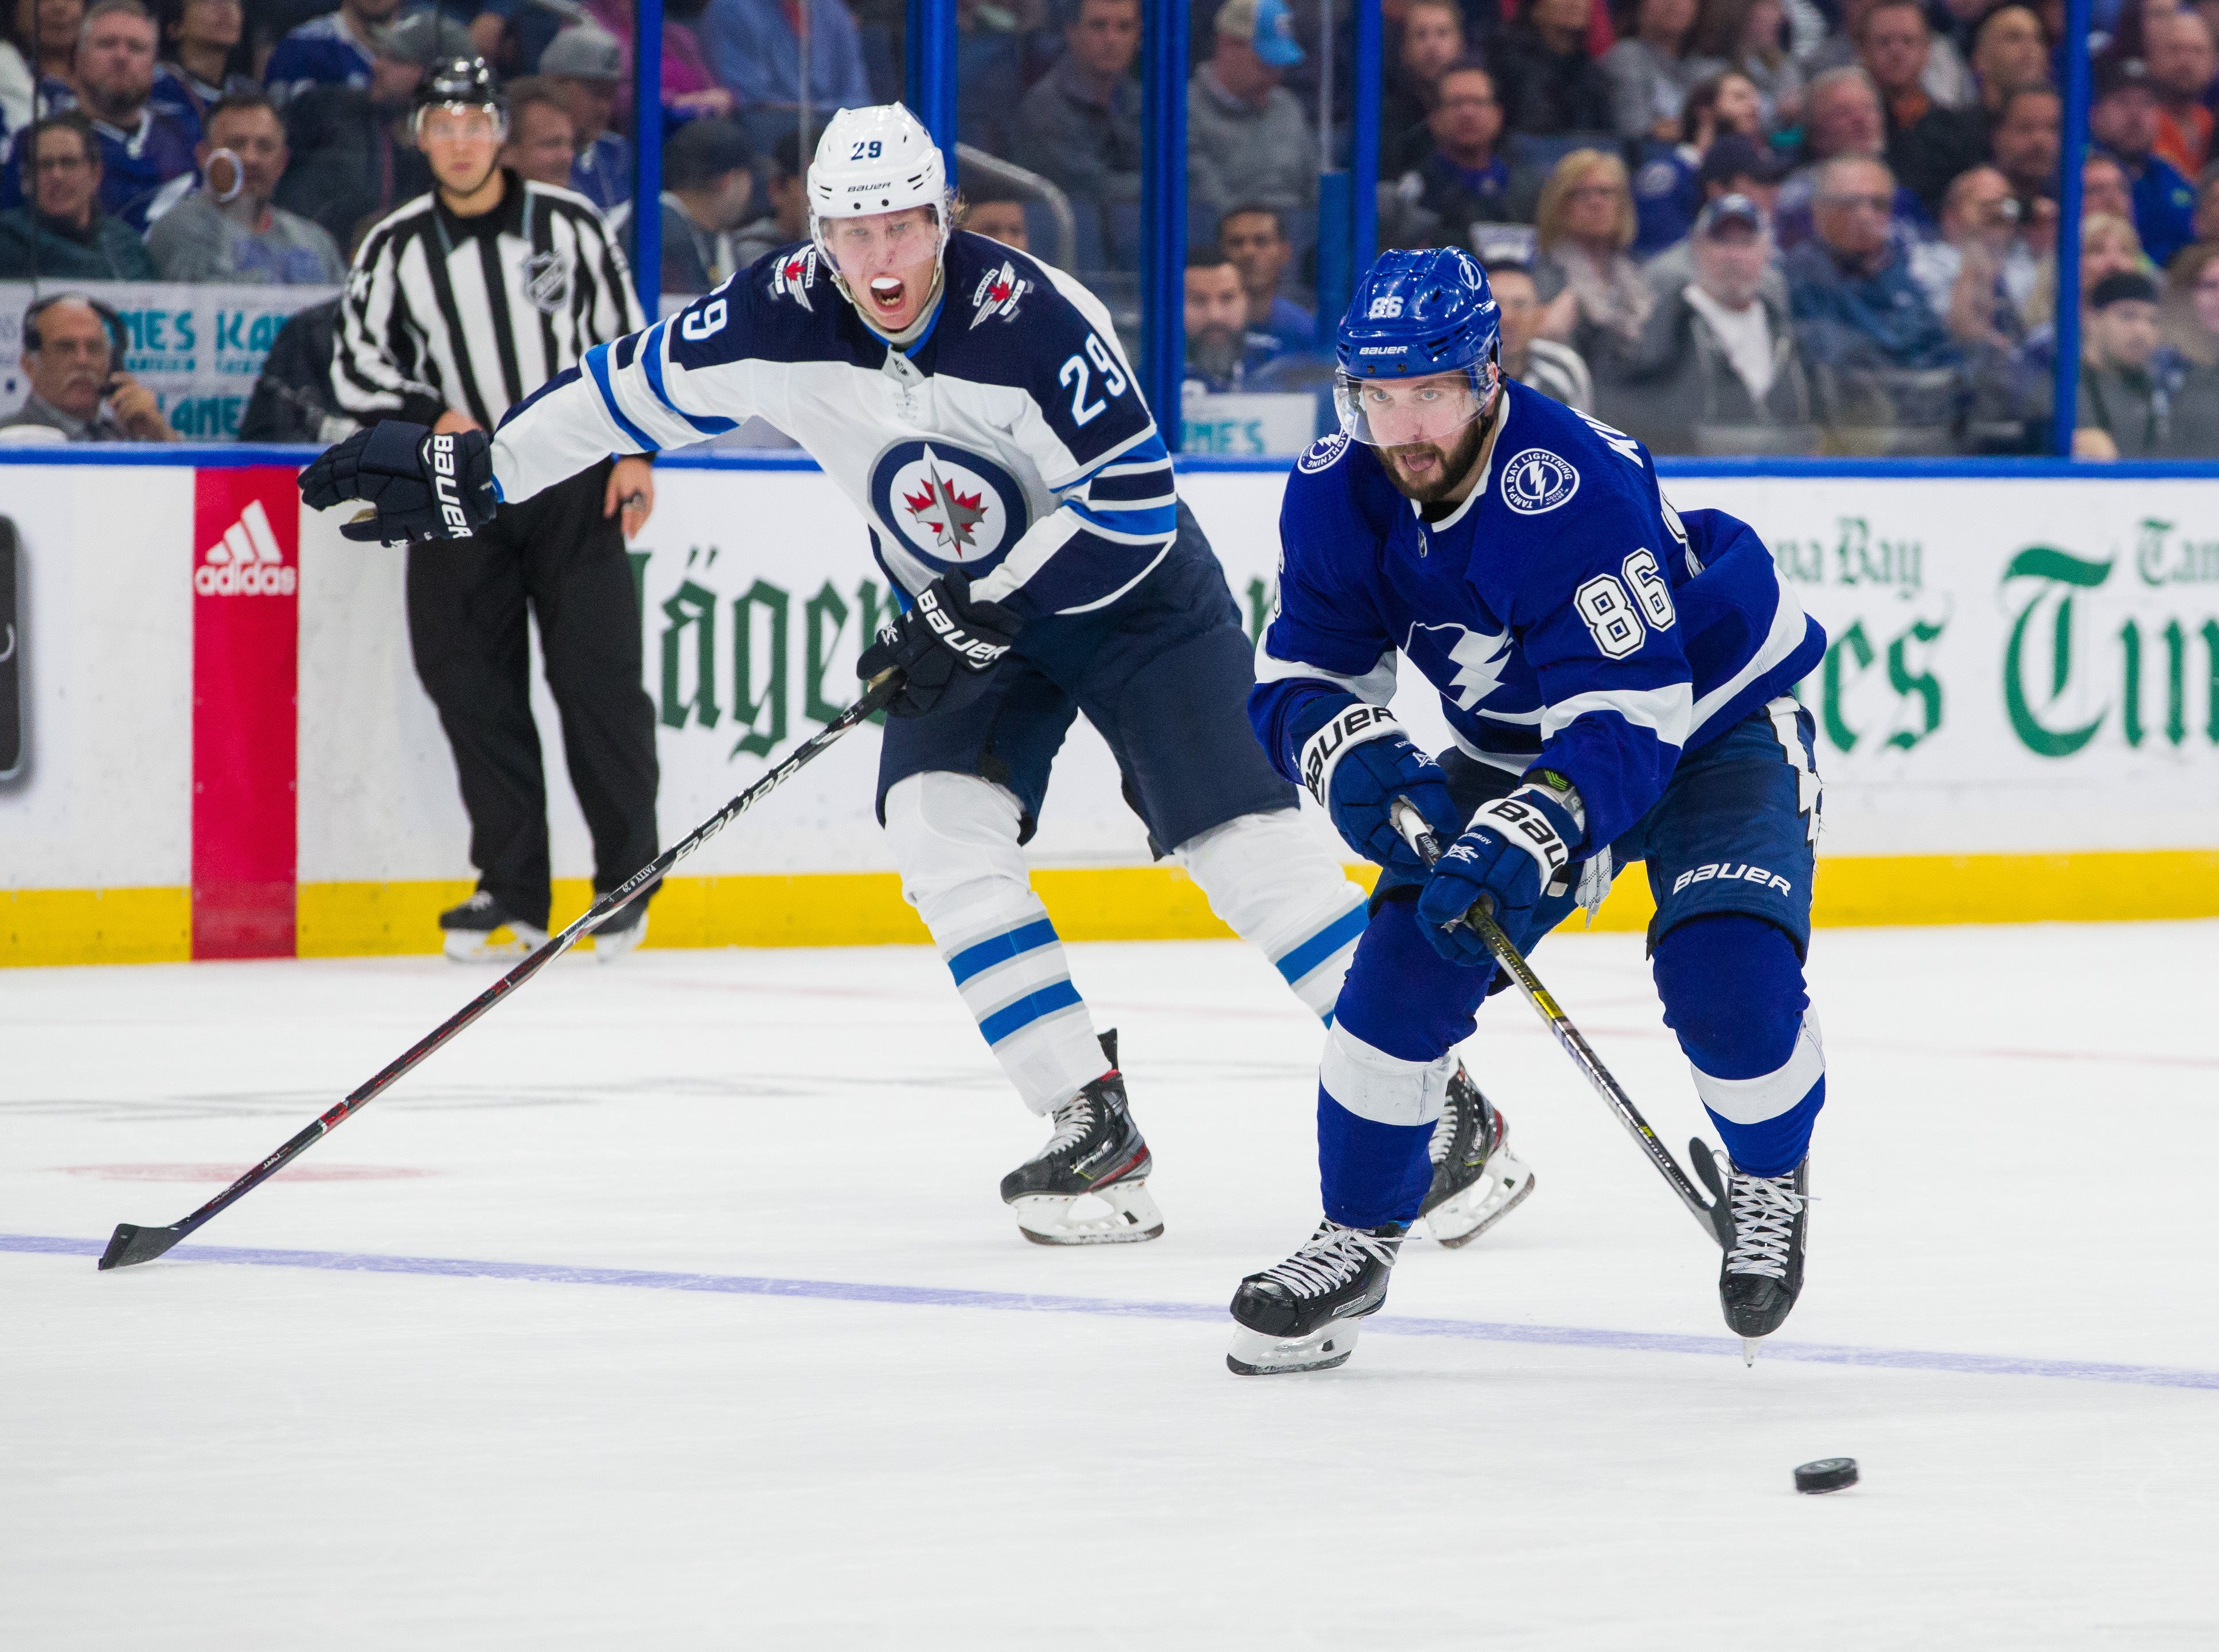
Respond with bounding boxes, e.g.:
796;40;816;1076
146;91;346;286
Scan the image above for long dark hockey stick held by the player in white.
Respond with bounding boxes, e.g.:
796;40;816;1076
100;672;901;1273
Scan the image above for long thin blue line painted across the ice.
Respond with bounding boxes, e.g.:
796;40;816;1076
0;1233;2219;1388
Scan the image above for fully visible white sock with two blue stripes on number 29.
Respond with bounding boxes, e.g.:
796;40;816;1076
886;772;1107;1113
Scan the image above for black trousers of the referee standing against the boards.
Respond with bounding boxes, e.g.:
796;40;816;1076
408;459;657;929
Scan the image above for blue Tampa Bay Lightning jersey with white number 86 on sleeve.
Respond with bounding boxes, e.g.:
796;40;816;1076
1249;384;1826;845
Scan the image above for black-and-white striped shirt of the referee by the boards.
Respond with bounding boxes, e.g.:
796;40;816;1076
330;173;646;430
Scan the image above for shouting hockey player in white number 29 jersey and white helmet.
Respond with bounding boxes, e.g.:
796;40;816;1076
302;104;1531;1244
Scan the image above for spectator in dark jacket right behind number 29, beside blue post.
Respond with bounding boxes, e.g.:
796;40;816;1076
1012;0;1141;204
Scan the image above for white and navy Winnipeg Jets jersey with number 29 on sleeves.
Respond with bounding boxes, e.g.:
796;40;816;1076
493;233;1178;619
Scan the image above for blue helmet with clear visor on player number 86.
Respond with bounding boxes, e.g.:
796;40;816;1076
1333;246;1502;448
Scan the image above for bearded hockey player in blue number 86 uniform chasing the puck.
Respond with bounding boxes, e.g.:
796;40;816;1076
1229;251;1826;1375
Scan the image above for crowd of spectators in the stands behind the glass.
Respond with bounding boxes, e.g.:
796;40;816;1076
0;0;2219;455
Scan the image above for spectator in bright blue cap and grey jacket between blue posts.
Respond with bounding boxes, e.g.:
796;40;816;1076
1187;0;1318;217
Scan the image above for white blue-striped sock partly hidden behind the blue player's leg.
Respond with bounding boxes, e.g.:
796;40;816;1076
1178;809;1364;1025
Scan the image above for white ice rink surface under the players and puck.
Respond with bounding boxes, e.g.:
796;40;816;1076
0;923;2219;1652
